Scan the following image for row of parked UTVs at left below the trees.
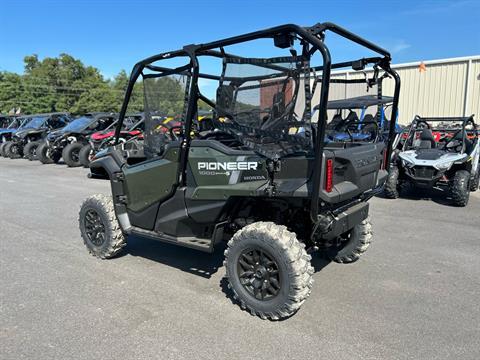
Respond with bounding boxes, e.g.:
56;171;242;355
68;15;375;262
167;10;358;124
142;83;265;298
0;112;144;167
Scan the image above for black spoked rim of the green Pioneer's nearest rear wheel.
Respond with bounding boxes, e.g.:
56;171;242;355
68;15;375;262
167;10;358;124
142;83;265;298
237;248;281;301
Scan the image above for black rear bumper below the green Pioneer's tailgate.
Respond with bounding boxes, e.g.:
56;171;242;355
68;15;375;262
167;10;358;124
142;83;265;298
315;201;369;240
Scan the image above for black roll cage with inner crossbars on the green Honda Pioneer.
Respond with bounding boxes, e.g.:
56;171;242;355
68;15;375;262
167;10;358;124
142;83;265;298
115;22;400;223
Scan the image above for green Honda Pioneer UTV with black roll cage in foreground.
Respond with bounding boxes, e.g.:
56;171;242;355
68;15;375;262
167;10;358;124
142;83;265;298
79;23;400;320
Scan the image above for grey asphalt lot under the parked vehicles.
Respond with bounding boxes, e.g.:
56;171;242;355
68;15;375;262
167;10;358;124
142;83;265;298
0;158;480;359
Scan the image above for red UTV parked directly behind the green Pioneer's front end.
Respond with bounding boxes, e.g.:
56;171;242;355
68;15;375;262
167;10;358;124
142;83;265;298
78;114;145;167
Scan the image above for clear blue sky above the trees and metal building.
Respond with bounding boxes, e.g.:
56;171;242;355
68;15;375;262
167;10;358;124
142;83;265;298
0;0;480;78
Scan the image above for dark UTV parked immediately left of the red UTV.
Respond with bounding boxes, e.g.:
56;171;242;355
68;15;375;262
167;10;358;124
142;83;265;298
37;113;118;167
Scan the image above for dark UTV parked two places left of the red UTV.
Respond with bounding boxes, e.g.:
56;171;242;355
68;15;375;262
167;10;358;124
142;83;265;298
4;113;71;160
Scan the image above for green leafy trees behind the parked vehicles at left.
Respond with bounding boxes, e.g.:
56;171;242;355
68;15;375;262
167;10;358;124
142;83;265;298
0;54;178;114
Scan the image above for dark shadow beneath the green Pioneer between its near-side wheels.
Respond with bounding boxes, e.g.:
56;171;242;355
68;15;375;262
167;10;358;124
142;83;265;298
123;236;225;279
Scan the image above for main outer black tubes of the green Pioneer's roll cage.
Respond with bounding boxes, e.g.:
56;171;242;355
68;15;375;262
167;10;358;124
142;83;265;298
115;22;400;224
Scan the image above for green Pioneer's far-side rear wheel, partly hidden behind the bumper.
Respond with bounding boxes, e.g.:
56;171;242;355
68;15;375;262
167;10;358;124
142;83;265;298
327;218;373;264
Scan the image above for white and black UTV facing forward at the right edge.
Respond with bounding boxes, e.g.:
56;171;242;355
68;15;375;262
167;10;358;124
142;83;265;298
384;115;480;206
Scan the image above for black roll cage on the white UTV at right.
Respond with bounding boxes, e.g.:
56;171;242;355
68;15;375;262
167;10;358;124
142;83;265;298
402;115;479;154
